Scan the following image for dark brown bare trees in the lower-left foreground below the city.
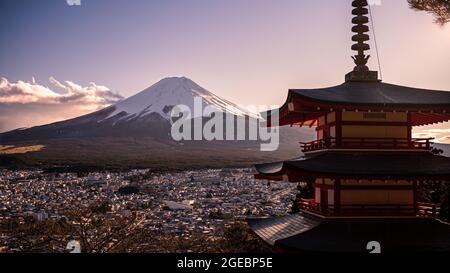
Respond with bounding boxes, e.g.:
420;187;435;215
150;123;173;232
0;205;150;253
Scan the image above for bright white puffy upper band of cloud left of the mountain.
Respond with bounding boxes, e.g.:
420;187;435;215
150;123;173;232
0;77;123;109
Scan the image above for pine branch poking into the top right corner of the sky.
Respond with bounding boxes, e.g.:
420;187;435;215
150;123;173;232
408;0;450;26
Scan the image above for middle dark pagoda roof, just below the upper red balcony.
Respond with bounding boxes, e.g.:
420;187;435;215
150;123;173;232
255;151;450;182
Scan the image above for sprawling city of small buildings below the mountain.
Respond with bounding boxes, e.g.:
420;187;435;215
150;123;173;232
0;169;297;252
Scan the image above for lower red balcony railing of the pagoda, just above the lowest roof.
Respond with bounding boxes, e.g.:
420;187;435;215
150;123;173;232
298;199;440;218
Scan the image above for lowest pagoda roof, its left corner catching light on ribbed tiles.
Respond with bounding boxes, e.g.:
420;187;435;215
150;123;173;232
247;212;450;253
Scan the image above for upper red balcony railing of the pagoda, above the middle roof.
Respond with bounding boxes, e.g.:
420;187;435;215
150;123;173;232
300;138;433;153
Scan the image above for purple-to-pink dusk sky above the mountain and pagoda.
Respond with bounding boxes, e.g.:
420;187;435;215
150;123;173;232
0;0;450;140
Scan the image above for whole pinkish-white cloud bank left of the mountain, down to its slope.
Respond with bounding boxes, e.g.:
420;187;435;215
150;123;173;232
0;77;123;132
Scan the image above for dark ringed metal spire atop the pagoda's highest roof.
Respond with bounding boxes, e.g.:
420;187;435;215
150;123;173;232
346;0;378;81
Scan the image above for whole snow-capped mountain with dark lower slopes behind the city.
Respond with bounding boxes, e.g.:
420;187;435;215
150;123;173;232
0;77;314;167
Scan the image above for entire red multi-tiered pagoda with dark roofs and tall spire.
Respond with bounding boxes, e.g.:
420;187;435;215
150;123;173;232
248;0;450;253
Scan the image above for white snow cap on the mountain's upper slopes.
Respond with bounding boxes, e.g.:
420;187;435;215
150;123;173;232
106;77;260;120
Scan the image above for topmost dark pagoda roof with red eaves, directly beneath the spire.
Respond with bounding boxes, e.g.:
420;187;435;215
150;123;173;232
262;80;450;126
